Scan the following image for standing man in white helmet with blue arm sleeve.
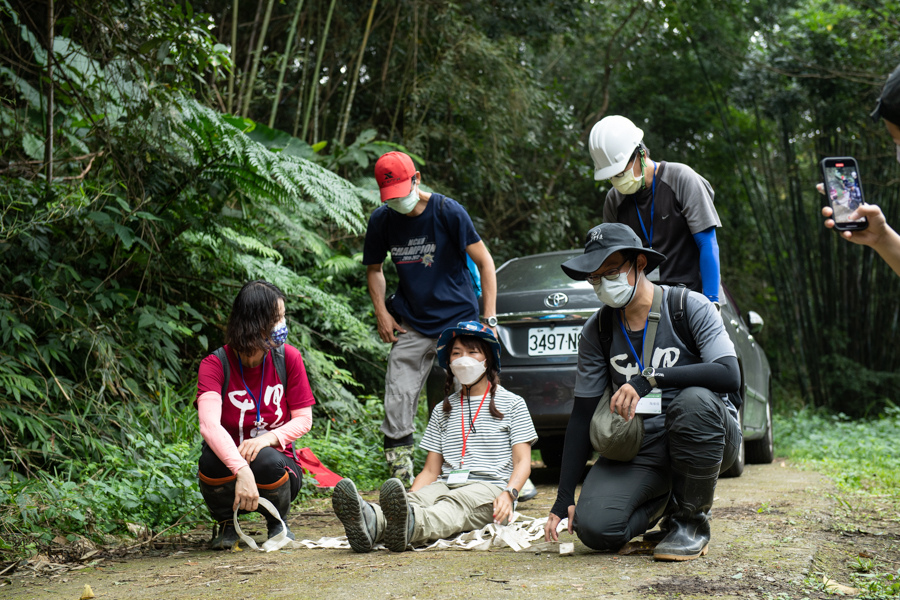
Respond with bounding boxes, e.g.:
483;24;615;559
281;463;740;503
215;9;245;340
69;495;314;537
589;115;722;302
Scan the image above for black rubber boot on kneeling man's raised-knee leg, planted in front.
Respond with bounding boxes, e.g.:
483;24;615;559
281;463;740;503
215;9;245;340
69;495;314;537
653;463;721;561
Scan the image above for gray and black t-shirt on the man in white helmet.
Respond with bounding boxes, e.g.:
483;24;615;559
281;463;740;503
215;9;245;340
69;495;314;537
603;162;722;292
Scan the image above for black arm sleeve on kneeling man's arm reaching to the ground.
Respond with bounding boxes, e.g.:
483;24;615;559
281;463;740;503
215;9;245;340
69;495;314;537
550;396;600;519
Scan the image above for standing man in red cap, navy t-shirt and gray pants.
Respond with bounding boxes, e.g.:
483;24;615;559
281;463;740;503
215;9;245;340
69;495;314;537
363;152;497;487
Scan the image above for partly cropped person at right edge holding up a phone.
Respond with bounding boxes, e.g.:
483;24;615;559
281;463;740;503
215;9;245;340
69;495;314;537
816;65;900;275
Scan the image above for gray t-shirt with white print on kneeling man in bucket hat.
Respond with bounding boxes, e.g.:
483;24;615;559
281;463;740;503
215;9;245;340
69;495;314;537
575;285;737;411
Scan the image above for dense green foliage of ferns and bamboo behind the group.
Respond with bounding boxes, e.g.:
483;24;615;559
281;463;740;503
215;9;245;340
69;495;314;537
0;0;900;556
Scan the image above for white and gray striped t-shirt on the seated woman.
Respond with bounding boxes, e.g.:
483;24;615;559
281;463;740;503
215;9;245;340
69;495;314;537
420;386;537;487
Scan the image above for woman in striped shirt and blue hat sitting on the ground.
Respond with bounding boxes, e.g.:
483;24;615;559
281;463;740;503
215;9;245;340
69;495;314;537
331;321;537;552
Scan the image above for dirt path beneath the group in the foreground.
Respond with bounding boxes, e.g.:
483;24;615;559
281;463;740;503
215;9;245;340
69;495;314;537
0;461;833;600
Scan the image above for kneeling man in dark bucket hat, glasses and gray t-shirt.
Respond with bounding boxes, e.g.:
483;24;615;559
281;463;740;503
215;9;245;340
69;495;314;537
545;223;741;561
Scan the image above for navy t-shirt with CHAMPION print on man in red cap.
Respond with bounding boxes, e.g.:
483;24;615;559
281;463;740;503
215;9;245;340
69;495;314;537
363;194;481;337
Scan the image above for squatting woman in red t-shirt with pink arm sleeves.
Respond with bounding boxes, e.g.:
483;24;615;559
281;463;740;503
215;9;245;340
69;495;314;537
196;281;315;550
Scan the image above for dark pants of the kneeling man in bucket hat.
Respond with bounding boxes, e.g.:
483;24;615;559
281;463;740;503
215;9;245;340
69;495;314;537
575;387;741;550
